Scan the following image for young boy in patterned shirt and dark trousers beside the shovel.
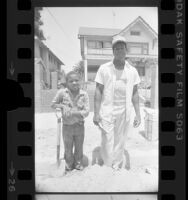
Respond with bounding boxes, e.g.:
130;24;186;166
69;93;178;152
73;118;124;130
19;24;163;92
52;71;89;172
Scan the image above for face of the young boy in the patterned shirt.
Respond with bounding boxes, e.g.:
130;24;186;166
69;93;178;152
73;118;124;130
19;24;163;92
67;74;80;92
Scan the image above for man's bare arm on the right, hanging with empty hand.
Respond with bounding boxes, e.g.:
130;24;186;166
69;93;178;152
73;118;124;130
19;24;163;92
132;85;141;128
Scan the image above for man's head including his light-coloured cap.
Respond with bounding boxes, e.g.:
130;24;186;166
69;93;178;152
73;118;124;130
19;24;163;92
112;35;127;60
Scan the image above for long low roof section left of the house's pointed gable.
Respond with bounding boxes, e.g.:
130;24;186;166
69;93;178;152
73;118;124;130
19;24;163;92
78;27;122;36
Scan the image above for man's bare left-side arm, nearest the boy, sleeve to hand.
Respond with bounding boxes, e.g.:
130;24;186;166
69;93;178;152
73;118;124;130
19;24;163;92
93;83;104;125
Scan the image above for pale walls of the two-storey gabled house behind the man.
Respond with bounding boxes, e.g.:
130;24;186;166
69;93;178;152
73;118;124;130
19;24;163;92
80;22;158;82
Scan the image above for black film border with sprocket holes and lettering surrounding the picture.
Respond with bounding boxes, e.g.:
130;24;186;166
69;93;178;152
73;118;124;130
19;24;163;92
7;0;186;200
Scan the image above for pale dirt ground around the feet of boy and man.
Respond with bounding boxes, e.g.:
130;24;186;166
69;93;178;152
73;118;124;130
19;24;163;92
35;109;158;192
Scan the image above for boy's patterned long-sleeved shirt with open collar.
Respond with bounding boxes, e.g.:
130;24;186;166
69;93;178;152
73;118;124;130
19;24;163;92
52;88;89;125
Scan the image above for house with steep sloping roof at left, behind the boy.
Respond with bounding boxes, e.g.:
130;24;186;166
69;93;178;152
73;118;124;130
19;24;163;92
34;37;65;89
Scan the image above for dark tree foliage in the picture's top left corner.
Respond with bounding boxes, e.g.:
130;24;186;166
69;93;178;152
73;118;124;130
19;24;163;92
35;7;46;40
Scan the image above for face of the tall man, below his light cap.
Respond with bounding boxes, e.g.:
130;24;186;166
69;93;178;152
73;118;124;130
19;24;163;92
113;42;126;60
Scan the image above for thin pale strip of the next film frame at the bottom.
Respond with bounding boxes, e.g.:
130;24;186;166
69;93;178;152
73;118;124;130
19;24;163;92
36;194;157;200
